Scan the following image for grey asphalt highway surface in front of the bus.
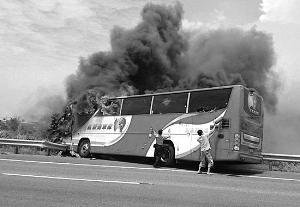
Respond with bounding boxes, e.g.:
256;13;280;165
0;154;300;207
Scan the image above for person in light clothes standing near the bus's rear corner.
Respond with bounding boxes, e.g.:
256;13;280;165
197;129;214;175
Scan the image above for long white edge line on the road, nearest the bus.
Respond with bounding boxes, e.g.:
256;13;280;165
0;159;300;182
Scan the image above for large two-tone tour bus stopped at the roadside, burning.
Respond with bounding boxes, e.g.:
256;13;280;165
72;85;264;164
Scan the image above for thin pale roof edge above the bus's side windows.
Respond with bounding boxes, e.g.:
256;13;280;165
110;85;246;100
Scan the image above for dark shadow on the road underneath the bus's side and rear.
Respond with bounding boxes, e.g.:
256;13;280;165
91;154;263;176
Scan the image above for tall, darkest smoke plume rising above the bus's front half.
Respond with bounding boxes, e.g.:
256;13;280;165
67;4;187;98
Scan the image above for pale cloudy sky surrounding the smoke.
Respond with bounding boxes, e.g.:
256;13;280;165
0;0;300;153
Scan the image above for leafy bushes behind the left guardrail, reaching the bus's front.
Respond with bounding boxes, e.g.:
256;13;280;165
0;90;100;143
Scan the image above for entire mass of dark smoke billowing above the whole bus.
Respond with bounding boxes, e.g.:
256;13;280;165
66;3;280;112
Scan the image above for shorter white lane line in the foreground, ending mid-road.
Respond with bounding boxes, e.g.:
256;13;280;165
2;173;144;185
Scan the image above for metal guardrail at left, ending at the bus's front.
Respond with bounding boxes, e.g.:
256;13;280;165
0;139;69;155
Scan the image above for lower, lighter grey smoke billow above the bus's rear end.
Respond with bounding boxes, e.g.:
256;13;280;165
183;28;280;112
